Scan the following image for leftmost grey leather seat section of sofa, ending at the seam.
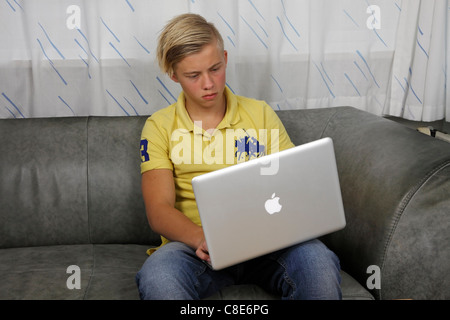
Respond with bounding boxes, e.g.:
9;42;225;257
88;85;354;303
0;245;94;300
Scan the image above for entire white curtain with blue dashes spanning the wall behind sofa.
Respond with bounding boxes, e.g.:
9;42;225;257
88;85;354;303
0;0;450;121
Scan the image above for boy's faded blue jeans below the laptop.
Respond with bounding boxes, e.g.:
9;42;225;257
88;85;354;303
136;240;342;300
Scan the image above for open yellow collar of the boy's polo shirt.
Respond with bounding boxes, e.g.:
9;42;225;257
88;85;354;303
175;87;240;131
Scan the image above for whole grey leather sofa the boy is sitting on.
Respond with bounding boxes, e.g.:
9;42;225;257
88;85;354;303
0;107;450;299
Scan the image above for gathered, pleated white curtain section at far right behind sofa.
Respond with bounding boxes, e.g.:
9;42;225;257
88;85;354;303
384;0;450;121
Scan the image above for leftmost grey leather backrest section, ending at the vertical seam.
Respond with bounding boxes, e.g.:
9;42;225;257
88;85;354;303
0;118;89;248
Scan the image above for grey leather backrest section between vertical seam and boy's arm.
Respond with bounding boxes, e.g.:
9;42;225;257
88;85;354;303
87;116;161;245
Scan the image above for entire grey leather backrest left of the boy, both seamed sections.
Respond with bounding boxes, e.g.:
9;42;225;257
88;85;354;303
0;116;160;248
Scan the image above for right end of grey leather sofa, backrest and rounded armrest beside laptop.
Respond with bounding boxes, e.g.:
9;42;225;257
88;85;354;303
278;107;450;299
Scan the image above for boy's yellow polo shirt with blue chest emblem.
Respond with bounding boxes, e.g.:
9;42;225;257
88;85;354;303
140;88;294;254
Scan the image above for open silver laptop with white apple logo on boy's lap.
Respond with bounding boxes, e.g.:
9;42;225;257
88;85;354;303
192;138;346;270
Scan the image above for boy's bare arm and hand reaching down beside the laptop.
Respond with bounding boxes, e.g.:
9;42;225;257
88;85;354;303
142;169;209;261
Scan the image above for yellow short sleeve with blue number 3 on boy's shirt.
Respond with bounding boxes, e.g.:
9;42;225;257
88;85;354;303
140;117;173;173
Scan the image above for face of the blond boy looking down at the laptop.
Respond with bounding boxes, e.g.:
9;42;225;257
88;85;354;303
172;42;227;109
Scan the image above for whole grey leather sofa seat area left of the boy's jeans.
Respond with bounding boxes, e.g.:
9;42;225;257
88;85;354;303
0;244;148;300
